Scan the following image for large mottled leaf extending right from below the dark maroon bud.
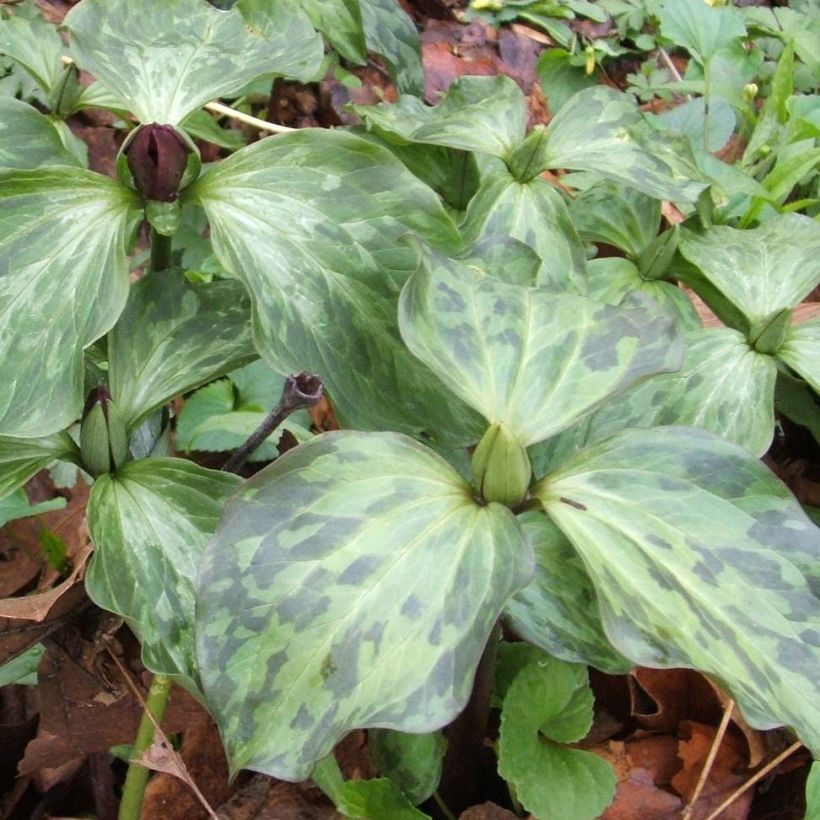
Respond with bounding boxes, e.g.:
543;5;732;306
195;130;481;441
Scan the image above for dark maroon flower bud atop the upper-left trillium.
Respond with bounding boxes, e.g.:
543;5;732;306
126;122;188;202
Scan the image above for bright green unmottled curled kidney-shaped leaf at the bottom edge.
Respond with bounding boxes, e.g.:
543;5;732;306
498;659;615;820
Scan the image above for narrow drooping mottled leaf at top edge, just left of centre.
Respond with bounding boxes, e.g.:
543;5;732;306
360;0;424;94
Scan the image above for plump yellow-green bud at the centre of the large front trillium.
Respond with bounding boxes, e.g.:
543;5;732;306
473;424;532;507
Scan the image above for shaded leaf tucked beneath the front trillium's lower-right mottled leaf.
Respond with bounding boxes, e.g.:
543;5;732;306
504;511;632;674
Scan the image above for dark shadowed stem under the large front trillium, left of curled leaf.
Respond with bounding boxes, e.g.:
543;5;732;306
438;623;500;815
